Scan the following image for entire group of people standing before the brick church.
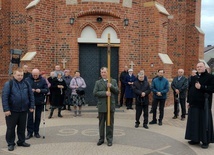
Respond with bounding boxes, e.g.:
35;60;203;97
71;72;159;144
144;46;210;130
2;62;214;151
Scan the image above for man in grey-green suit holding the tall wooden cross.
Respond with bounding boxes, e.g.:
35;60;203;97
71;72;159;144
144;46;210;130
93;67;119;146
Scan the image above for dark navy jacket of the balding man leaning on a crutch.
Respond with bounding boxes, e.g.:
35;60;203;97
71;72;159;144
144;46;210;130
25;75;49;105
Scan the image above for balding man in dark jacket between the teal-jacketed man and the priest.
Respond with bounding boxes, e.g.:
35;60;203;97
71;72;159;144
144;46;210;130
171;69;188;120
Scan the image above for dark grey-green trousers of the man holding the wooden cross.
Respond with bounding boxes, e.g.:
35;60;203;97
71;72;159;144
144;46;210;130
99;112;114;142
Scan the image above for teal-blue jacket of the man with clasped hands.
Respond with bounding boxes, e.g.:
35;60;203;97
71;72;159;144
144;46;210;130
152;77;169;99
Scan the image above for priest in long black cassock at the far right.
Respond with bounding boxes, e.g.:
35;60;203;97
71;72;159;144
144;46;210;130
185;62;214;149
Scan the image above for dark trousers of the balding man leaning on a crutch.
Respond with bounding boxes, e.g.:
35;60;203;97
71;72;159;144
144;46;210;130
27;105;44;134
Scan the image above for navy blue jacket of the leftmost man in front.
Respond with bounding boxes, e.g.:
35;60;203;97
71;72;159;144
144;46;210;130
2;79;34;112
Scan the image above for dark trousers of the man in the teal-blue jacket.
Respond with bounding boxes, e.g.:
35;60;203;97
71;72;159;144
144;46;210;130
152;99;166;122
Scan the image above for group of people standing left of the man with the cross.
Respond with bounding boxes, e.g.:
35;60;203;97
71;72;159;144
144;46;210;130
2;65;86;151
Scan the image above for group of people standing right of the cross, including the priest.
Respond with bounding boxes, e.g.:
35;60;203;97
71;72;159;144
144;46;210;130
120;62;214;148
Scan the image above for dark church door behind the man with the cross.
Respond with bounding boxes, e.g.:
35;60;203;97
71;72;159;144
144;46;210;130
79;44;118;105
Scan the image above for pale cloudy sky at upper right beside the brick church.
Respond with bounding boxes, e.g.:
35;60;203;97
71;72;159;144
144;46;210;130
201;0;214;46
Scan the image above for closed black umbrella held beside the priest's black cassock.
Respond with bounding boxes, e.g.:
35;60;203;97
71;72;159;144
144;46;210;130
204;93;209;143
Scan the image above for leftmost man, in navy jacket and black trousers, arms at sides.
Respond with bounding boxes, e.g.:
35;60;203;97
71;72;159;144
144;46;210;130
2;68;34;151
